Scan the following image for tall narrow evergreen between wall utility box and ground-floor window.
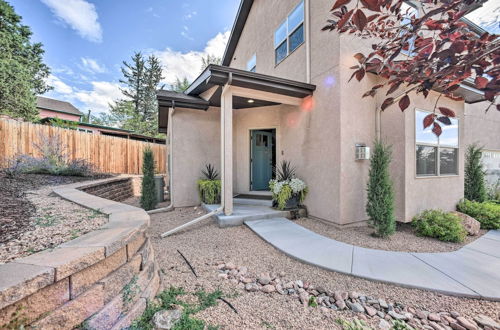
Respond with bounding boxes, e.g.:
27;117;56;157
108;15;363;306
366;141;396;237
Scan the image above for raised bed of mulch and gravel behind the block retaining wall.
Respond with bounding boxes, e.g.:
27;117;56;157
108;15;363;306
0;174;107;263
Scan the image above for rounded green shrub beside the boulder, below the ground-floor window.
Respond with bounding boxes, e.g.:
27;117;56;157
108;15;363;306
412;210;467;242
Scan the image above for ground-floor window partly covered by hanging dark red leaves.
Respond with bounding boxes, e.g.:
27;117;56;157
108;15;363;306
415;110;459;177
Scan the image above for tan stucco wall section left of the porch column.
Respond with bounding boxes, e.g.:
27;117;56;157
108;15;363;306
172;108;220;207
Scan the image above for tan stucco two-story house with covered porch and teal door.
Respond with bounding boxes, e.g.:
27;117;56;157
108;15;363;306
158;0;500;225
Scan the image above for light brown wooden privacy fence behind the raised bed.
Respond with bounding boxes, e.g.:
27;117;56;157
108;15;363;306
0;118;166;174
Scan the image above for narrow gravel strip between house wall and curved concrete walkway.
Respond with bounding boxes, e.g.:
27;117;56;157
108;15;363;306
296;218;487;252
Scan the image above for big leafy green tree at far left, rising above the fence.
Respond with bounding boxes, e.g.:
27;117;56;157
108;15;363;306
0;0;50;120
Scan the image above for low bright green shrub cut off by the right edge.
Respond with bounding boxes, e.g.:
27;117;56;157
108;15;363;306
457;199;500;229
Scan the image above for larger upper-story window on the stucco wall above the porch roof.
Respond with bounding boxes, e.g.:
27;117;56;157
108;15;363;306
274;1;304;64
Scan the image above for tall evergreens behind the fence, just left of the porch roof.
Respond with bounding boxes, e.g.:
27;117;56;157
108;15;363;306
110;52;163;136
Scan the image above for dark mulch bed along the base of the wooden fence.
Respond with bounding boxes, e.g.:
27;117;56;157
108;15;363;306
0;171;109;244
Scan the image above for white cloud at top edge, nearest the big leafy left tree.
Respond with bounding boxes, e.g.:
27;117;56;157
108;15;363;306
41;0;102;42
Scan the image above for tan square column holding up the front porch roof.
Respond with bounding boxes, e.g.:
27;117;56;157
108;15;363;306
220;85;233;215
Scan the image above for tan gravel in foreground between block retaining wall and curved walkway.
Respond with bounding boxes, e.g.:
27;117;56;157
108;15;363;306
149;208;500;329
